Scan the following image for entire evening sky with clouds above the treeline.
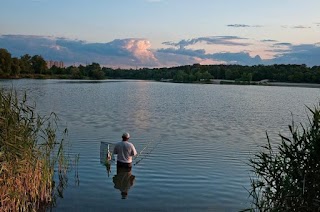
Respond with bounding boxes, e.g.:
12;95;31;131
0;0;320;68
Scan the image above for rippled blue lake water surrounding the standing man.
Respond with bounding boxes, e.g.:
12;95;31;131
0;80;320;211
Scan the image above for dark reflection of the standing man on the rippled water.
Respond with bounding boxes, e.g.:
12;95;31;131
113;167;135;199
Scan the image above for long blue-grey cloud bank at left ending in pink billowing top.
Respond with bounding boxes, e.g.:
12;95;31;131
0;35;159;67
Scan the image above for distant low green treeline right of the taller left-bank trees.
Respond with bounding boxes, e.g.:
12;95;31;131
105;64;320;83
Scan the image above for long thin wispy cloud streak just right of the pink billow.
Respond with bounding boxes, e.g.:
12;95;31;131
162;36;250;48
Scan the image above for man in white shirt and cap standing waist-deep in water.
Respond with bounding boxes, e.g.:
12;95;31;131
113;133;137;171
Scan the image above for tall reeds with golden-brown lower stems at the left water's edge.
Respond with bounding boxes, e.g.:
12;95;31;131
0;90;68;211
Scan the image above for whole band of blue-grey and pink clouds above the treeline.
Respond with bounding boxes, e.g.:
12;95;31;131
0;35;320;68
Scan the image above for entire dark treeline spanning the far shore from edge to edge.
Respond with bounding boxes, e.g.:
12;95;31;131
0;49;320;83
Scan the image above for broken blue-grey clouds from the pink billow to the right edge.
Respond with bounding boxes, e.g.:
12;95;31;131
158;36;320;66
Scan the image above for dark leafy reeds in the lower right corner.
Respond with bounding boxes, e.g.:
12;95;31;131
250;107;320;211
